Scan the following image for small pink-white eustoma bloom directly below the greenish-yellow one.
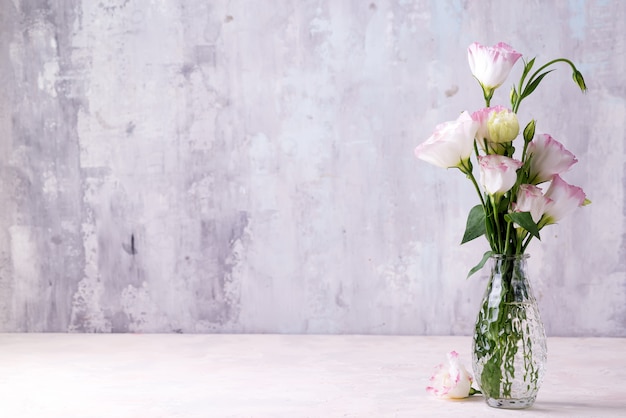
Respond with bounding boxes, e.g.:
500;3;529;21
478;154;522;196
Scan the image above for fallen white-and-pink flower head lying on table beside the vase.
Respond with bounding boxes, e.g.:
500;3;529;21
426;351;480;399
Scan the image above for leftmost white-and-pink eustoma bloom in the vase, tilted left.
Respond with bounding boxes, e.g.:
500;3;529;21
415;112;478;168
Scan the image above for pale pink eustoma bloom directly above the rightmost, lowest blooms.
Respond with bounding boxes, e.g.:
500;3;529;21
527;134;578;184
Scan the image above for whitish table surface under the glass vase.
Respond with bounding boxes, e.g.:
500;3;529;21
0;334;626;418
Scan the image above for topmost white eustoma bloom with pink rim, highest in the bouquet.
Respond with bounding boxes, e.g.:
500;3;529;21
467;42;522;91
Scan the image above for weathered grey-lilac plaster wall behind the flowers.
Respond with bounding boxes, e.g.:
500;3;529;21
0;0;626;336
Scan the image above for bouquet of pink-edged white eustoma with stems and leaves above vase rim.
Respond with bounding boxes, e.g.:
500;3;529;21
415;42;590;276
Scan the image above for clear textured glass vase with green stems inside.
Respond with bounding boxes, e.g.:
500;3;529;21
472;254;547;409
